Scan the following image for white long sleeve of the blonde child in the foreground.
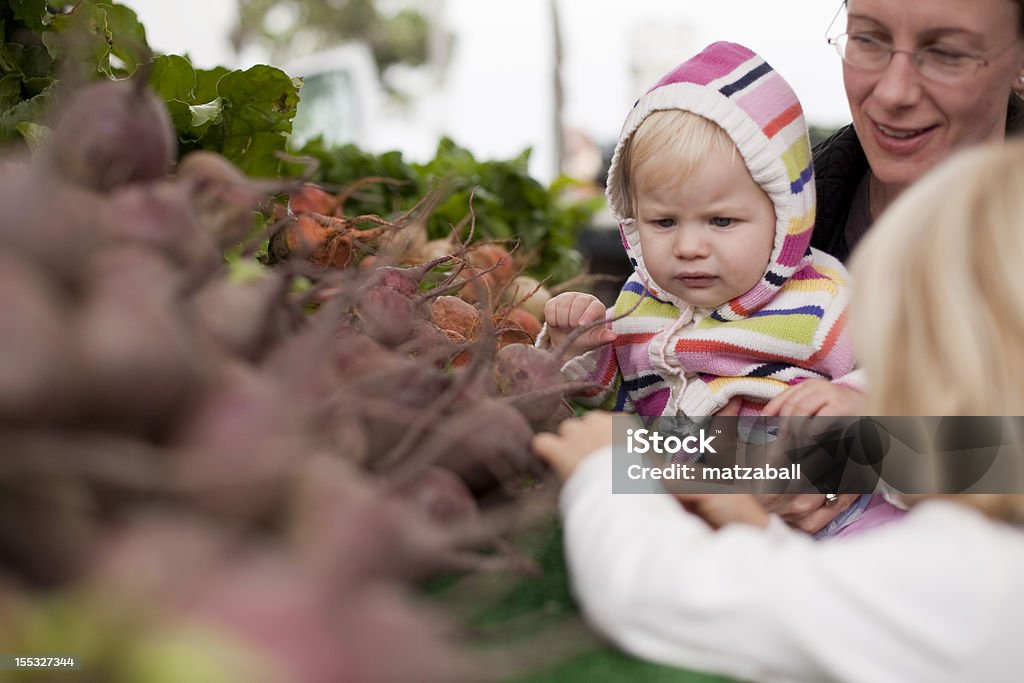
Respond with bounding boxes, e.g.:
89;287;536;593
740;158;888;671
560;449;1024;683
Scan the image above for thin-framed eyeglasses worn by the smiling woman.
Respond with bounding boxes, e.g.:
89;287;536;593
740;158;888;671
827;33;1003;85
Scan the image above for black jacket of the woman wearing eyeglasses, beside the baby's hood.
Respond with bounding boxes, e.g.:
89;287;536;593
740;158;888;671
811;95;1024;261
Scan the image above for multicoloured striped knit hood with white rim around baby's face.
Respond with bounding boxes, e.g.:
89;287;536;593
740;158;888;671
607;42;814;321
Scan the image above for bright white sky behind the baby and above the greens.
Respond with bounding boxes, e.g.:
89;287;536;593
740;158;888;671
122;0;849;180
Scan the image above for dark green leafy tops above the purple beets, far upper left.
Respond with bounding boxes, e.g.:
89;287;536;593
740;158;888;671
0;0;298;176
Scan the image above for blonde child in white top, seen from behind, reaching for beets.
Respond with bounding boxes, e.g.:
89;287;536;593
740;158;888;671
535;140;1024;682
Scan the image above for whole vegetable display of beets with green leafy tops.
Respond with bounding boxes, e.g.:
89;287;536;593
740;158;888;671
0;0;737;683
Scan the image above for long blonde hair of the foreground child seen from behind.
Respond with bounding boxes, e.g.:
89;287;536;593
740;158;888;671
851;140;1024;523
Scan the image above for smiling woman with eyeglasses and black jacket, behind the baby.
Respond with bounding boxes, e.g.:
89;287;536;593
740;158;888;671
762;0;1024;532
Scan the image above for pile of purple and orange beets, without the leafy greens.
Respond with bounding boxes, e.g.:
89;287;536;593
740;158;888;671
0;68;579;683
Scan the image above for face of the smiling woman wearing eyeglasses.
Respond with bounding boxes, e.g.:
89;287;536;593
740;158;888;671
843;0;1024;190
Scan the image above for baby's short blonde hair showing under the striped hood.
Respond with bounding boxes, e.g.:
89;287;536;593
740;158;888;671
618;110;738;218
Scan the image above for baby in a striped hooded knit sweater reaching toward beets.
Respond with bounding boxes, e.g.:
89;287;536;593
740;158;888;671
539;43;898;535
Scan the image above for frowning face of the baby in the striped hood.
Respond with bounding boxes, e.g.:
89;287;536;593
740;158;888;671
635;150;775;307
